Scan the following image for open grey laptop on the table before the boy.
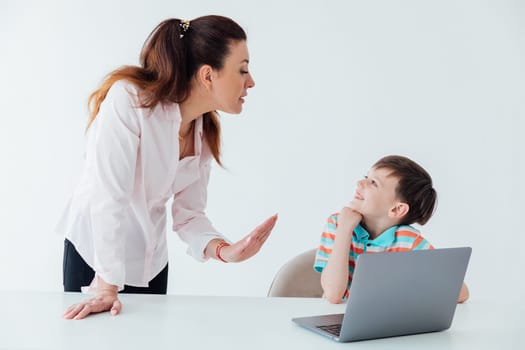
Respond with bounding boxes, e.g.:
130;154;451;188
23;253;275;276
292;247;472;342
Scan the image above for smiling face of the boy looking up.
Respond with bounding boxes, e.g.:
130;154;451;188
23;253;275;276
350;168;399;220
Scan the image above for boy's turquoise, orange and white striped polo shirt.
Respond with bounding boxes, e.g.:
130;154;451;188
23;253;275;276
314;213;434;299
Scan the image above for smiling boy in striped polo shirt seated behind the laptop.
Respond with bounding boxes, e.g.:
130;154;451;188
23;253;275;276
314;156;469;304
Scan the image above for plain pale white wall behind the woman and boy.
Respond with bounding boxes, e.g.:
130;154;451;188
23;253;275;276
0;0;525;300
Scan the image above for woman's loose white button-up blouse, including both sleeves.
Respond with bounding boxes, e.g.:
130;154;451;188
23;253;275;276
57;81;224;289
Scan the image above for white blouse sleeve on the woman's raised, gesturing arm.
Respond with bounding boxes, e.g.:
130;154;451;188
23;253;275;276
172;159;226;261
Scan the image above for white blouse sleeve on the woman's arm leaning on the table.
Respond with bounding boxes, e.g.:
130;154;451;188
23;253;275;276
86;82;140;289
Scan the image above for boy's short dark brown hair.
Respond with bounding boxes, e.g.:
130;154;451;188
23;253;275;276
373;155;437;225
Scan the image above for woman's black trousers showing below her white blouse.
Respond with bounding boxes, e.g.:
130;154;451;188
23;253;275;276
62;239;168;294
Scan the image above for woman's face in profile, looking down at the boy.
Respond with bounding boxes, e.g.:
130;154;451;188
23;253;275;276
212;41;255;114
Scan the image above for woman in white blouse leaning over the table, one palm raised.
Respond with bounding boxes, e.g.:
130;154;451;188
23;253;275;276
59;16;277;319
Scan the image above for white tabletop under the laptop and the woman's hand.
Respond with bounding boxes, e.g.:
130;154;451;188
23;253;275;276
0;292;525;350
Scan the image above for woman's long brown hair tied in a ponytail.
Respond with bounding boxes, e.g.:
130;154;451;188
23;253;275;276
87;16;246;165
